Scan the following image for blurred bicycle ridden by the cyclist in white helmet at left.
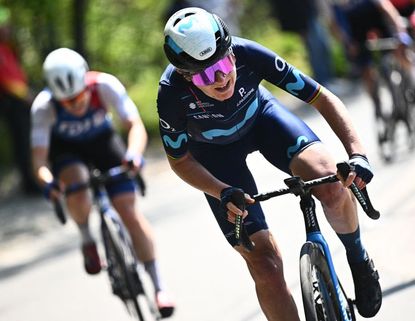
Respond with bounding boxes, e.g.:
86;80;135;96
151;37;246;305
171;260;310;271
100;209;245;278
54;166;161;321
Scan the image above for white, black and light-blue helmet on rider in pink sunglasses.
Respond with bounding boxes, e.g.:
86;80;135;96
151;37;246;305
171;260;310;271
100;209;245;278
164;7;232;72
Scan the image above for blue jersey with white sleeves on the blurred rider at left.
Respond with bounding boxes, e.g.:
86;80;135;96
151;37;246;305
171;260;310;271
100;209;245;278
31;71;139;147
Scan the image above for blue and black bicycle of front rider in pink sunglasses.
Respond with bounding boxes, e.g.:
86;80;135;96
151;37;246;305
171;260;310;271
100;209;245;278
235;162;380;321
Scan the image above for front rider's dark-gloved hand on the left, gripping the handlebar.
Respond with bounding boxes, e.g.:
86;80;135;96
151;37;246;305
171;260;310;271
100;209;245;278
220;187;255;223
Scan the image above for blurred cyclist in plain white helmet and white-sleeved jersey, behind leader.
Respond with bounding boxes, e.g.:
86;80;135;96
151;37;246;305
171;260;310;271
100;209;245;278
31;48;174;316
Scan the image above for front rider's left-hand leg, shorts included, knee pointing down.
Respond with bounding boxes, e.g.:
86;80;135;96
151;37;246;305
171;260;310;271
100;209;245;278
190;133;299;321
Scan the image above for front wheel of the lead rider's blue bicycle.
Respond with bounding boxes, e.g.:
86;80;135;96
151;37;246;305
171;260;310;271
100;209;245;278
300;242;342;321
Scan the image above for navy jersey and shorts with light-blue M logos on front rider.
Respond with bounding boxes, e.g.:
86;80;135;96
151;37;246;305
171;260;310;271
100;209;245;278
157;37;321;246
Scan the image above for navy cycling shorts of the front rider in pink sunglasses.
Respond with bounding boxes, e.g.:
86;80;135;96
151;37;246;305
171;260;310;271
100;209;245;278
189;99;320;246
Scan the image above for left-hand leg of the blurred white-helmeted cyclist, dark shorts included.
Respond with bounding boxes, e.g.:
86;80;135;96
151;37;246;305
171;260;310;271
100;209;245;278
49;136;101;274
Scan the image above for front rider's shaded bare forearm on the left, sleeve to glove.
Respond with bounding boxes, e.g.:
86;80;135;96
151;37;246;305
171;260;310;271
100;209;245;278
168;152;229;199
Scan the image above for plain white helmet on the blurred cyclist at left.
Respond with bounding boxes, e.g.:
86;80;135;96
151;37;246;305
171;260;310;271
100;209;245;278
43;48;89;100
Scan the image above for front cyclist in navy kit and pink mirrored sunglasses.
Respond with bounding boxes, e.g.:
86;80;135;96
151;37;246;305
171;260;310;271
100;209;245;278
157;8;381;320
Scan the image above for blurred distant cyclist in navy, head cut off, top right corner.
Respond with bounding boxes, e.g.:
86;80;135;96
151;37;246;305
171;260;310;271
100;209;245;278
328;0;415;140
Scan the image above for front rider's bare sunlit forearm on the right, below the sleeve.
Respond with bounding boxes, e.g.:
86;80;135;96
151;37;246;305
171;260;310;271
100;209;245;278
312;89;366;156
